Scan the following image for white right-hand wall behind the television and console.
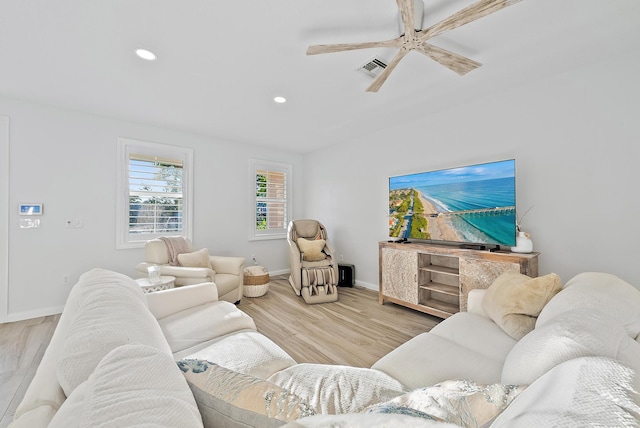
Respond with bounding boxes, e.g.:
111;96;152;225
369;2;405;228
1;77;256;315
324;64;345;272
304;50;640;289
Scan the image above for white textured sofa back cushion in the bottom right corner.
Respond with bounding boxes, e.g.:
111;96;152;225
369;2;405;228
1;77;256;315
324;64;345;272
491;357;640;428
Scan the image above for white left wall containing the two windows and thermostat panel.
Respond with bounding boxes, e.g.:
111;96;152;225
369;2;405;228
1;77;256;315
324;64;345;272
0;98;304;321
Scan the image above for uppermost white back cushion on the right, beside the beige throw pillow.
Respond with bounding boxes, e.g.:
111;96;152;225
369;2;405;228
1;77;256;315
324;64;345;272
536;272;640;338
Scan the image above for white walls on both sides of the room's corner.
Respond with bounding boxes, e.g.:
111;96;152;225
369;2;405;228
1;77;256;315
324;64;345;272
0;47;640;322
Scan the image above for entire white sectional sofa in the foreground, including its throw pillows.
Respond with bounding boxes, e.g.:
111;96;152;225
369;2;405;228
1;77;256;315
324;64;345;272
11;270;640;427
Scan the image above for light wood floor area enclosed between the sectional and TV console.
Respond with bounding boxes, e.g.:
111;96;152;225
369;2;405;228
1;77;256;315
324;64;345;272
238;275;441;367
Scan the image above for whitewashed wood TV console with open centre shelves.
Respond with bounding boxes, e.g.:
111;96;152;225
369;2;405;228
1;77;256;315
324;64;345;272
379;242;538;318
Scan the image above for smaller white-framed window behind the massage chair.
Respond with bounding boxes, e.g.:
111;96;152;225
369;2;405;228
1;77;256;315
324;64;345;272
249;159;291;239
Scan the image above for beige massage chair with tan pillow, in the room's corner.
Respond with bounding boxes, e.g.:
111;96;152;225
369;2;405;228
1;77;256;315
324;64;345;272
287;220;338;304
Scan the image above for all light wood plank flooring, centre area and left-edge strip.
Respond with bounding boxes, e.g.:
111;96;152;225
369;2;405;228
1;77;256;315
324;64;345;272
0;275;440;428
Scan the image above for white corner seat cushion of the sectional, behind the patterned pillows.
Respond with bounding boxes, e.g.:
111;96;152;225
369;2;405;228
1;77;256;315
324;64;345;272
180;331;296;379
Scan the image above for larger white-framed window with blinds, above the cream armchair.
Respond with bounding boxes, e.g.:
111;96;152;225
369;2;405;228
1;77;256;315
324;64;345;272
116;138;193;248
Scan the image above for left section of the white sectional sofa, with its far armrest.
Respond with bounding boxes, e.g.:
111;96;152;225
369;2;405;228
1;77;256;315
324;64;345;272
10;269;260;427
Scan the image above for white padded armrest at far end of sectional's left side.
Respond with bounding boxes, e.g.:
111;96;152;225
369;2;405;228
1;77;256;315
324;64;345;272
145;282;218;319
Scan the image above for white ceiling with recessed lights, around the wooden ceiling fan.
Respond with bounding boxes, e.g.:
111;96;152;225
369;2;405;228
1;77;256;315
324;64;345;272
0;0;640;152
